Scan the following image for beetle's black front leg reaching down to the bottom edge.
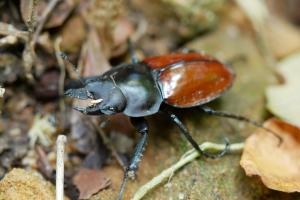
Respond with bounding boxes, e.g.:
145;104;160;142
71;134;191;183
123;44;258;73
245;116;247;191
117;118;148;200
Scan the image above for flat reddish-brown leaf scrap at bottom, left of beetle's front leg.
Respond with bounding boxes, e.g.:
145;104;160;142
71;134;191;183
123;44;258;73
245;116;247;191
73;168;111;199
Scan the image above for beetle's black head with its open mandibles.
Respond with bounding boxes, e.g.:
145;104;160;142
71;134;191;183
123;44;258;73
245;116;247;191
65;78;126;115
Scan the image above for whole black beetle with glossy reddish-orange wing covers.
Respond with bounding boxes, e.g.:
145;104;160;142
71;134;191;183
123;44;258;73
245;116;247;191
65;52;280;199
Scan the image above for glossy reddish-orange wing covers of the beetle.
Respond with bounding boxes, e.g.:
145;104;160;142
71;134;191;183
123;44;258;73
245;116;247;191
143;53;235;108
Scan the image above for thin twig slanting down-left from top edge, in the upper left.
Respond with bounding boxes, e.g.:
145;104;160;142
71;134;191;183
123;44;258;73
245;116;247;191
32;0;61;44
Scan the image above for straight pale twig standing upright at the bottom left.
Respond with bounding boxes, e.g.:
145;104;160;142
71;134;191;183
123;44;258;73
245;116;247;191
56;135;67;200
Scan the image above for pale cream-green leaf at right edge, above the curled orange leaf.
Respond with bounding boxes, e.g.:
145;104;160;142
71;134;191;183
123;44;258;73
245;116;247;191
266;52;300;127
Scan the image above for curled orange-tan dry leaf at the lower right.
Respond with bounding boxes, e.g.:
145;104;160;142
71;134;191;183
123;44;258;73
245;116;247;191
240;118;300;192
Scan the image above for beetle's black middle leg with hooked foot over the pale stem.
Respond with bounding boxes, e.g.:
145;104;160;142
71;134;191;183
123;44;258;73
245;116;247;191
166;111;229;159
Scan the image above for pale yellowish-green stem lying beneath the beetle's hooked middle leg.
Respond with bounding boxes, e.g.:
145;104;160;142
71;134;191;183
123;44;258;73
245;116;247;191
132;142;244;200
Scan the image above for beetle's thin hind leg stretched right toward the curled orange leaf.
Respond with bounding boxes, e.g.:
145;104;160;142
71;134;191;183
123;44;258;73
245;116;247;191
200;106;282;145
